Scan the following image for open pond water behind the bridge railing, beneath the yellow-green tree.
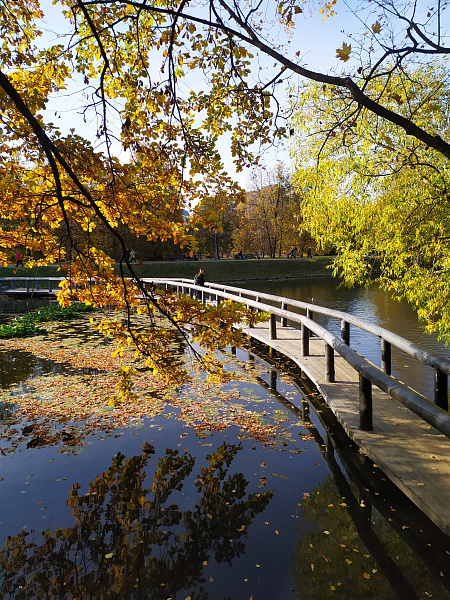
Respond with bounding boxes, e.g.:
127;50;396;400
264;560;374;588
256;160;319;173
246;277;450;398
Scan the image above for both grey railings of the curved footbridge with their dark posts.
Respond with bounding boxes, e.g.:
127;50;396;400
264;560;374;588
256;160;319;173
149;279;450;437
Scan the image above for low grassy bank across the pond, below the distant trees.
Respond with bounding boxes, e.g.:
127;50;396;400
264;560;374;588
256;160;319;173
0;256;332;282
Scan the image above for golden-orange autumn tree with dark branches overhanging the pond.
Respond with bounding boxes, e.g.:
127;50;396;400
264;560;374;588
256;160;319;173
0;0;450;376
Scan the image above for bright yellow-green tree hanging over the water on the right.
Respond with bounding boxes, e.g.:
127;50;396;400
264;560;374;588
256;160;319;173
293;65;450;339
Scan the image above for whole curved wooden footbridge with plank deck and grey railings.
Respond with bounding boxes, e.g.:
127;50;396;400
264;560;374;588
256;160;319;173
150;279;450;534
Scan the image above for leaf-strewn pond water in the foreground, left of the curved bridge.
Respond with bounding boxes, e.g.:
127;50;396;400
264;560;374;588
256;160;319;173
0;288;450;600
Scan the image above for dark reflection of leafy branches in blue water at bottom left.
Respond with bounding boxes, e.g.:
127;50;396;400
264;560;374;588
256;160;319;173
0;443;273;600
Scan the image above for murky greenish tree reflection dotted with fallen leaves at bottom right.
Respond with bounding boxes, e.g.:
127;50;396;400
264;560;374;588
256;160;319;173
293;477;450;600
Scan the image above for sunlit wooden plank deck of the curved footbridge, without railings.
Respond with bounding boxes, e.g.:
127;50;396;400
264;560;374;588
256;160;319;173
241;323;450;534
